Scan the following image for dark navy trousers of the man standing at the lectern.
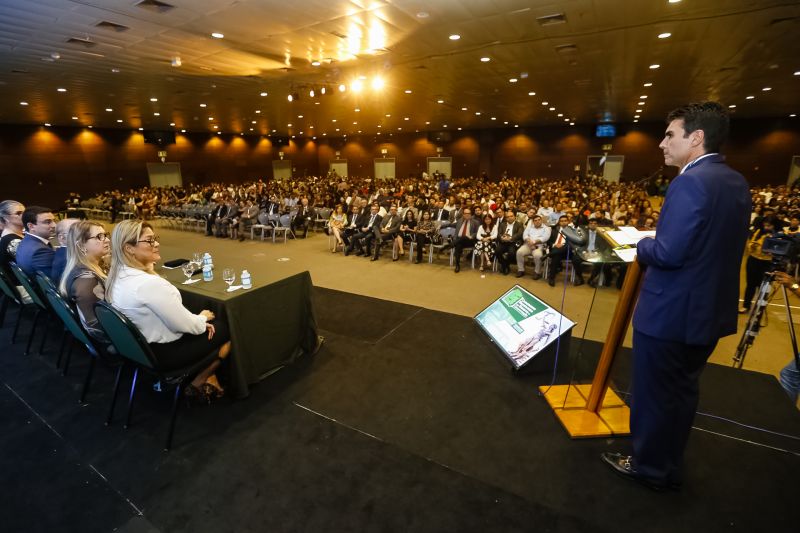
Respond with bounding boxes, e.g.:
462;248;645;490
630;330;716;484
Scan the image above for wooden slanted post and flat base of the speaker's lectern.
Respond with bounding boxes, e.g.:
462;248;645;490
539;236;642;439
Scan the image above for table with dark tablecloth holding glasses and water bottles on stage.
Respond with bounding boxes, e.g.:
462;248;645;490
160;265;318;398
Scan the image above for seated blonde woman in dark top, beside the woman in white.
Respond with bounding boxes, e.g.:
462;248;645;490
58;219;111;344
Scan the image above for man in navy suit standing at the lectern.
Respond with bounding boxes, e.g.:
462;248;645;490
602;102;751;489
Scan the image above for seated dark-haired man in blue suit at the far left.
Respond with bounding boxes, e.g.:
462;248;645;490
17;205;56;280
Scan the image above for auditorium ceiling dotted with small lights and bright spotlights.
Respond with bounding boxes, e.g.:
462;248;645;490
0;0;800;136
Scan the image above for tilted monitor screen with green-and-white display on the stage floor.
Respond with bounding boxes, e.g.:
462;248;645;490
475;285;575;368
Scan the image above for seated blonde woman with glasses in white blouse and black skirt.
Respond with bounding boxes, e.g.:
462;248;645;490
106;220;231;401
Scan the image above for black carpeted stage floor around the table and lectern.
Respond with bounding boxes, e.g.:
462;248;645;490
0;288;800;533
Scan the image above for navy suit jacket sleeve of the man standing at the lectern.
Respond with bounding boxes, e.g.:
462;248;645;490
637;174;710;270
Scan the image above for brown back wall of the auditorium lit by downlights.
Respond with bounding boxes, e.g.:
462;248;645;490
0;118;800;206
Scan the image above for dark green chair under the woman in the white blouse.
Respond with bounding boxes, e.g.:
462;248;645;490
94;302;222;451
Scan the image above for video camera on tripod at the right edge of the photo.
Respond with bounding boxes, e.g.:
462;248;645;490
733;232;800;368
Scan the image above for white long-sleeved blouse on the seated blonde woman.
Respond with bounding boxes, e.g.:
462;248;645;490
111;266;206;342
